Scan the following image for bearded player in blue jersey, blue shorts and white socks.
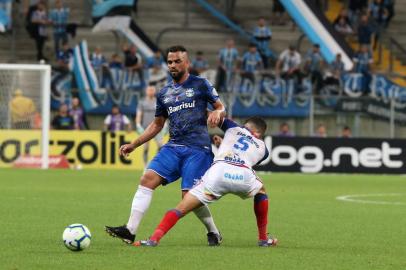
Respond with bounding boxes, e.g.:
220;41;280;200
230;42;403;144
106;45;225;246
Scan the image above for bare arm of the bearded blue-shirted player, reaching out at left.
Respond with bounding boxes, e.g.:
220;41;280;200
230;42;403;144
120;116;166;156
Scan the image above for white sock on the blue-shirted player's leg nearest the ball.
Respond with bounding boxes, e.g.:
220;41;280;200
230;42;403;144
127;185;154;234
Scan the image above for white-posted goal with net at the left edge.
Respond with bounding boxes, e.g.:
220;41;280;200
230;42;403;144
0;64;51;168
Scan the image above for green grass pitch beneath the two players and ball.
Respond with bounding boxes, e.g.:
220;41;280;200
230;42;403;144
0;169;406;270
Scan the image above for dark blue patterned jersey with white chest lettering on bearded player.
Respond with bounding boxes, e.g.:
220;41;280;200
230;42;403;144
155;75;219;151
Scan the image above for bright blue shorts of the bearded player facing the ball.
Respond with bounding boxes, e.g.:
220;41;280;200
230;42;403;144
147;145;213;190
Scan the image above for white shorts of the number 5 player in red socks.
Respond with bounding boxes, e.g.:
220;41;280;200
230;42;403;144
189;162;263;204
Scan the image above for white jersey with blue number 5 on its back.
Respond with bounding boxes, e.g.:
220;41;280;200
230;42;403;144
214;119;269;168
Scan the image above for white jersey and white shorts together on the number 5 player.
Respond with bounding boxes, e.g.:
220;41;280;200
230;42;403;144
189;119;269;204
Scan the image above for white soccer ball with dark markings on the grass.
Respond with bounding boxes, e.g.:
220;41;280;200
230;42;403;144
62;224;92;251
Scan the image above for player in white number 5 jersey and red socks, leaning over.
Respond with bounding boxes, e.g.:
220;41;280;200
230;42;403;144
134;117;278;247
